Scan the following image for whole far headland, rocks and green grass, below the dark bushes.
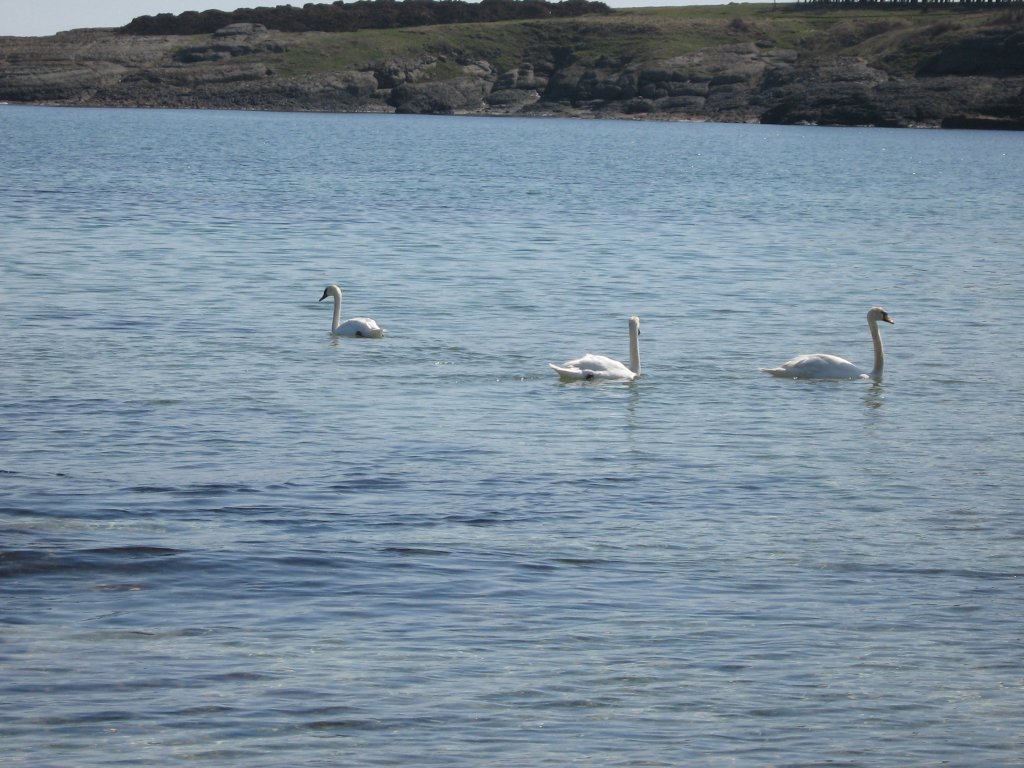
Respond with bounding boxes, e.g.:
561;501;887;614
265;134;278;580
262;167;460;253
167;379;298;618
0;5;1024;129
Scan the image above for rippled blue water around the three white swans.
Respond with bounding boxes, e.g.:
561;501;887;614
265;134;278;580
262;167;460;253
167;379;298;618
0;106;1024;768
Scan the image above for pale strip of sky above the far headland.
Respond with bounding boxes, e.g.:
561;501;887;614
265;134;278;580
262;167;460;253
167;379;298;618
0;0;728;37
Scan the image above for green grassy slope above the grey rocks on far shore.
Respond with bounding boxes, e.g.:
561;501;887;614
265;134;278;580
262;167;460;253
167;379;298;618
276;3;1015;77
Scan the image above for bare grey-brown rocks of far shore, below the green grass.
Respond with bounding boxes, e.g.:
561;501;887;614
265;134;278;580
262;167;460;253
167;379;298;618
0;10;1024;130
